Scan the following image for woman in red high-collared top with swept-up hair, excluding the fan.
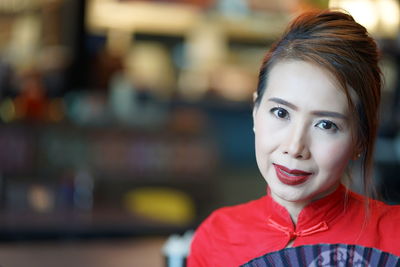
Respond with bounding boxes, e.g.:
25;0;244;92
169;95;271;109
188;11;400;266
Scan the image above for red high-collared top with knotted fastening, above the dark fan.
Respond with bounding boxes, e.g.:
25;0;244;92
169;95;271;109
188;186;400;267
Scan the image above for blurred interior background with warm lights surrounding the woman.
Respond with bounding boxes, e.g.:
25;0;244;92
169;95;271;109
0;0;400;267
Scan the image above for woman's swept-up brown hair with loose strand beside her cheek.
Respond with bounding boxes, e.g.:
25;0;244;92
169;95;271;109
255;10;382;200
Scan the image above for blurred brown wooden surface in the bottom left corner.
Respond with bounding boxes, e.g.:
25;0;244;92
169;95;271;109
0;237;166;267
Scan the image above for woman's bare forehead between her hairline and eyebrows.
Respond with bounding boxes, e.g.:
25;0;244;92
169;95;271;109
264;60;349;113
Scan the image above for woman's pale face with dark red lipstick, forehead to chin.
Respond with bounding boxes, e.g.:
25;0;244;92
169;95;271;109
253;60;354;205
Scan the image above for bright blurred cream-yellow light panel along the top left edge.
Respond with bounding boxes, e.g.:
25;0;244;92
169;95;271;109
87;0;201;35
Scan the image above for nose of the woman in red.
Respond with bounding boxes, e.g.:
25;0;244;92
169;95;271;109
282;125;311;160
